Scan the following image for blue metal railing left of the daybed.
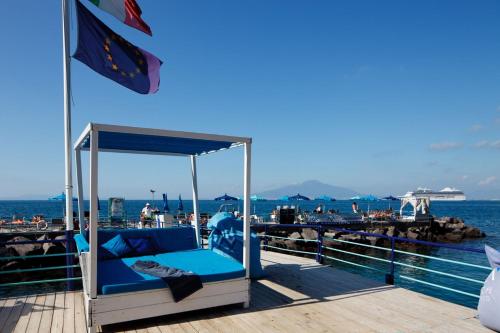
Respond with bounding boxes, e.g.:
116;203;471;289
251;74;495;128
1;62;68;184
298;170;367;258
0;230;82;290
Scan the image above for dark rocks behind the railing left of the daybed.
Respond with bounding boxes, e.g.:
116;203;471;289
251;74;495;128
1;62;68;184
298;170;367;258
0;234;75;283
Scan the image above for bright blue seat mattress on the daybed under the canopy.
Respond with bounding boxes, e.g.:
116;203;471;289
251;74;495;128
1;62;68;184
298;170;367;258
97;249;245;295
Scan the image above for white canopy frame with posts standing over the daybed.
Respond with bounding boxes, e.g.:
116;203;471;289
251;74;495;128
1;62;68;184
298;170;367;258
74;123;252;299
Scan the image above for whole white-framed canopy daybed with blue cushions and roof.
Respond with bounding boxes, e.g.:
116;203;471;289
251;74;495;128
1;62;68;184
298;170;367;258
74;123;252;333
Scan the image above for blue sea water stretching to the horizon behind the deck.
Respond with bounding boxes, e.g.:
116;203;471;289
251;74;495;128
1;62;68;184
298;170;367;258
0;200;500;307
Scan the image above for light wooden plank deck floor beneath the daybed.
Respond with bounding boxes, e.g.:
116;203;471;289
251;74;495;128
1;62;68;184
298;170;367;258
0;252;491;333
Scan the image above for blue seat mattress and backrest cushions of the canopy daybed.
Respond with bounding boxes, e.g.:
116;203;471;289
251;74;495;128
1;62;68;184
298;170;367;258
75;226;245;295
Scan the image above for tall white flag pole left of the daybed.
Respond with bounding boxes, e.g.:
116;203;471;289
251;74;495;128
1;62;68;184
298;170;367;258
61;0;73;230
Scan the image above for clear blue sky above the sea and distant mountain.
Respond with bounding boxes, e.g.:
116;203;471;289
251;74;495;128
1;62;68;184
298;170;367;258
0;0;500;199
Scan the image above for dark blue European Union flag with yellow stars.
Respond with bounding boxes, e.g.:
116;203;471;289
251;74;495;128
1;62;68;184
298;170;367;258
73;1;162;94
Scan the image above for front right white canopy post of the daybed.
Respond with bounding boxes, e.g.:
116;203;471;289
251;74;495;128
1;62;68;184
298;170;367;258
243;142;252;279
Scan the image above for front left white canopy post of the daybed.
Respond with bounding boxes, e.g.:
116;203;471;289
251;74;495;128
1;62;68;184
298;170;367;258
88;129;99;298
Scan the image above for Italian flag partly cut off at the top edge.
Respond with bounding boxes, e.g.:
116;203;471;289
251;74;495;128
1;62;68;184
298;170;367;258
90;0;153;36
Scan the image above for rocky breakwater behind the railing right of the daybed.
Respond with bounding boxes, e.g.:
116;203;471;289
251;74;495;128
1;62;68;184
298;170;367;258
259;217;486;252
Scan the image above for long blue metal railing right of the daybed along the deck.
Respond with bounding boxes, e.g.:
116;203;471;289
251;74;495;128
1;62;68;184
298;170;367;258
252;224;491;299
